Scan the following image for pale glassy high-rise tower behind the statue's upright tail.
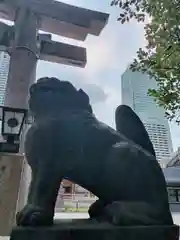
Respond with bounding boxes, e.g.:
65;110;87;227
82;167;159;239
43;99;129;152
121;69;173;167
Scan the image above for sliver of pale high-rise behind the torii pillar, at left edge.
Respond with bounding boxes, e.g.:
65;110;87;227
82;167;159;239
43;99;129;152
0;52;10;105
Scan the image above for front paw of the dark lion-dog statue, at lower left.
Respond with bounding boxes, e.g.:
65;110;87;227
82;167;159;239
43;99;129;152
16;204;53;226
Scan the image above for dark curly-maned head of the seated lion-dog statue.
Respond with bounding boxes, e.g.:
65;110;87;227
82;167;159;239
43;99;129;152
29;77;92;116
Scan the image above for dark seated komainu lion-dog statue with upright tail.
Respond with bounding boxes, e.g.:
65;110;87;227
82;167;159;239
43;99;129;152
17;78;173;226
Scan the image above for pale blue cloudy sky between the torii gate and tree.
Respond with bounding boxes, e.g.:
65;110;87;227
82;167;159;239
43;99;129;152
37;0;180;149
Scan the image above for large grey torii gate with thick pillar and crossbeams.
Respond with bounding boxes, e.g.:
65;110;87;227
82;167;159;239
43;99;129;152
0;0;109;236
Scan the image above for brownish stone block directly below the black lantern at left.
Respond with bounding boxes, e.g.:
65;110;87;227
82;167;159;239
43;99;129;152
0;154;24;236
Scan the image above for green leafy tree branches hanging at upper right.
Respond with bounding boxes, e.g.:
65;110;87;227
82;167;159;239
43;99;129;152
111;0;180;123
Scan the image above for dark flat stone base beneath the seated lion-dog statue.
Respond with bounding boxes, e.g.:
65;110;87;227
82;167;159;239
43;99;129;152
10;220;179;240
